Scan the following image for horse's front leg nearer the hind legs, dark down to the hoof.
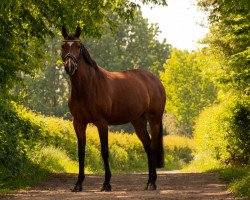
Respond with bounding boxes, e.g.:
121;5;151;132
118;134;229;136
96;121;111;192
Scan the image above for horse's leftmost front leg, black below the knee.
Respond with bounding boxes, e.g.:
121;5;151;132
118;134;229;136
72;120;87;192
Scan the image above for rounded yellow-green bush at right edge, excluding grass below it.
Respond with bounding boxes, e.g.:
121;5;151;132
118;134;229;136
194;97;250;166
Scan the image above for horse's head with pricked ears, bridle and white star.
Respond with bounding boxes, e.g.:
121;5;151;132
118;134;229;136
62;26;82;76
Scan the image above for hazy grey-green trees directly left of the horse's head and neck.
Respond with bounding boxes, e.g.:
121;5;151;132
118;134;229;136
20;33;70;118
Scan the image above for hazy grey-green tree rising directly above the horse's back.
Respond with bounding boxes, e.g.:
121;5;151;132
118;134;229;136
84;9;171;74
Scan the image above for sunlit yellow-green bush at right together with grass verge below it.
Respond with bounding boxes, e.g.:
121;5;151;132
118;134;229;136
187;95;250;197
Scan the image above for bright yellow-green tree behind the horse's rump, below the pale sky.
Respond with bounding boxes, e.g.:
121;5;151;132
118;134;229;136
161;50;216;136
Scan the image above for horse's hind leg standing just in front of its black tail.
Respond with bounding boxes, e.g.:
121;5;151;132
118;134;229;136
132;115;156;190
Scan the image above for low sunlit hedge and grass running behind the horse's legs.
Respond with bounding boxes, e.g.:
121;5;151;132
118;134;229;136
0;103;193;191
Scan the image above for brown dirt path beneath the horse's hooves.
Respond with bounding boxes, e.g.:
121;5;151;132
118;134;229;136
2;171;234;200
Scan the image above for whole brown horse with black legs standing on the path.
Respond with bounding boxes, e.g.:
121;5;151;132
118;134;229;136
62;26;166;192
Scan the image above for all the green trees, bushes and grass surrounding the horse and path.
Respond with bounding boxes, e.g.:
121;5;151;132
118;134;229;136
0;0;250;198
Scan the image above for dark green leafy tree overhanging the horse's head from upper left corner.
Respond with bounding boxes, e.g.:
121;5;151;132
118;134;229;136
0;0;166;98
